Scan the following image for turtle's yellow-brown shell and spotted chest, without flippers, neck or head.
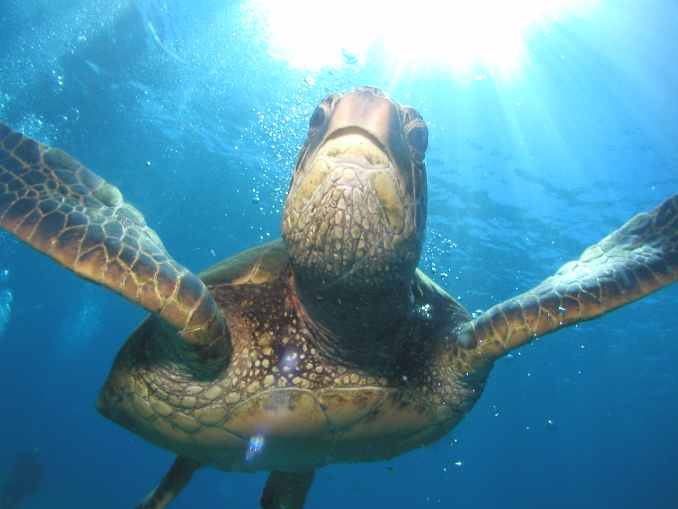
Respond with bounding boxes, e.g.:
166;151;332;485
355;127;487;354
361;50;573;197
98;242;480;471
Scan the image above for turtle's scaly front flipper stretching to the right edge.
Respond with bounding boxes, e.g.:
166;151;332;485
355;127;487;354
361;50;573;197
458;195;678;358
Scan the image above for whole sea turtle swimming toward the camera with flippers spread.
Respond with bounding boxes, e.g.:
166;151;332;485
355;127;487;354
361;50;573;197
0;87;678;509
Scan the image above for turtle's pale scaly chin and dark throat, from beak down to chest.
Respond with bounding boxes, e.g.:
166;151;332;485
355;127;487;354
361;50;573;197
283;131;423;367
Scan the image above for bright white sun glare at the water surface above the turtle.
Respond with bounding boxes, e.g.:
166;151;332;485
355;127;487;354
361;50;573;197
246;0;595;72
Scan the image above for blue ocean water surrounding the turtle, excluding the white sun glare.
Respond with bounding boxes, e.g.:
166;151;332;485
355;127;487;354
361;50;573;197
0;0;678;509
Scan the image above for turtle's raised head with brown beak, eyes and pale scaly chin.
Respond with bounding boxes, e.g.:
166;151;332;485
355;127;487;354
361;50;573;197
282;87;428;291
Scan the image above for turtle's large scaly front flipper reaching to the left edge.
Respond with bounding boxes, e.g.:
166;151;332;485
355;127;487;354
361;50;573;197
0;123;230;356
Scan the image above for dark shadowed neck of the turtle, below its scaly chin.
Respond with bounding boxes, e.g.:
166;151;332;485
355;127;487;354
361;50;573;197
290;276;414;370
